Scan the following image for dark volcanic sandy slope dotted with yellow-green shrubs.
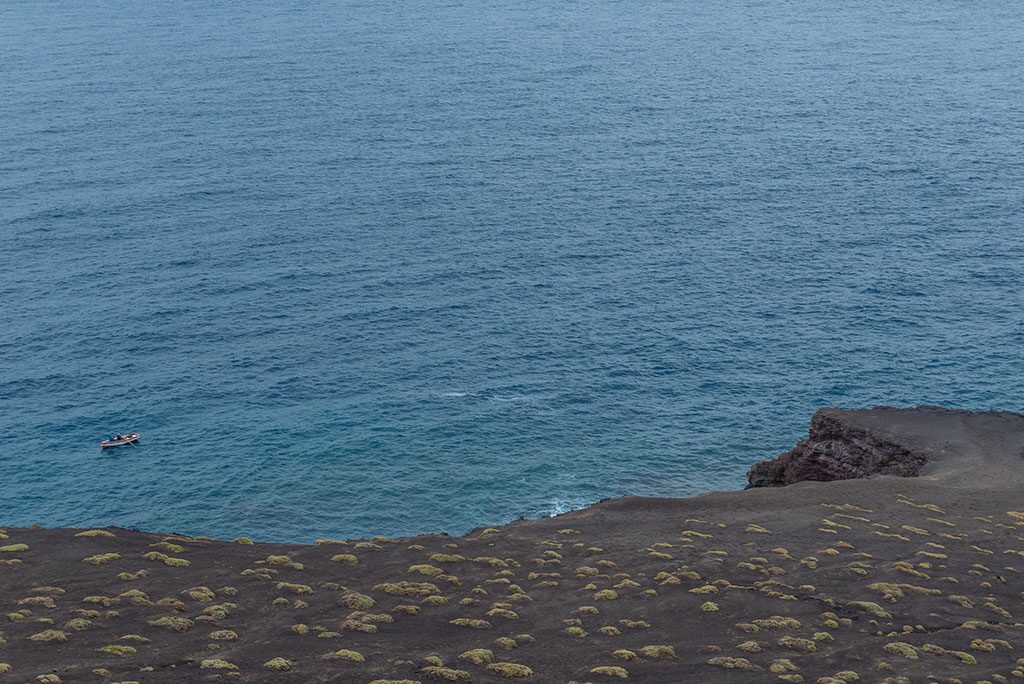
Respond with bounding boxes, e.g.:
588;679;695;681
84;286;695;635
0;409;1024;684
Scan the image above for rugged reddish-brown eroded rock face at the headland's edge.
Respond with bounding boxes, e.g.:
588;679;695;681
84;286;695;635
746;409;927;488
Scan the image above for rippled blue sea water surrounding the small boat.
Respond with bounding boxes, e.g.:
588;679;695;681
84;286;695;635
0;0;1024;541
